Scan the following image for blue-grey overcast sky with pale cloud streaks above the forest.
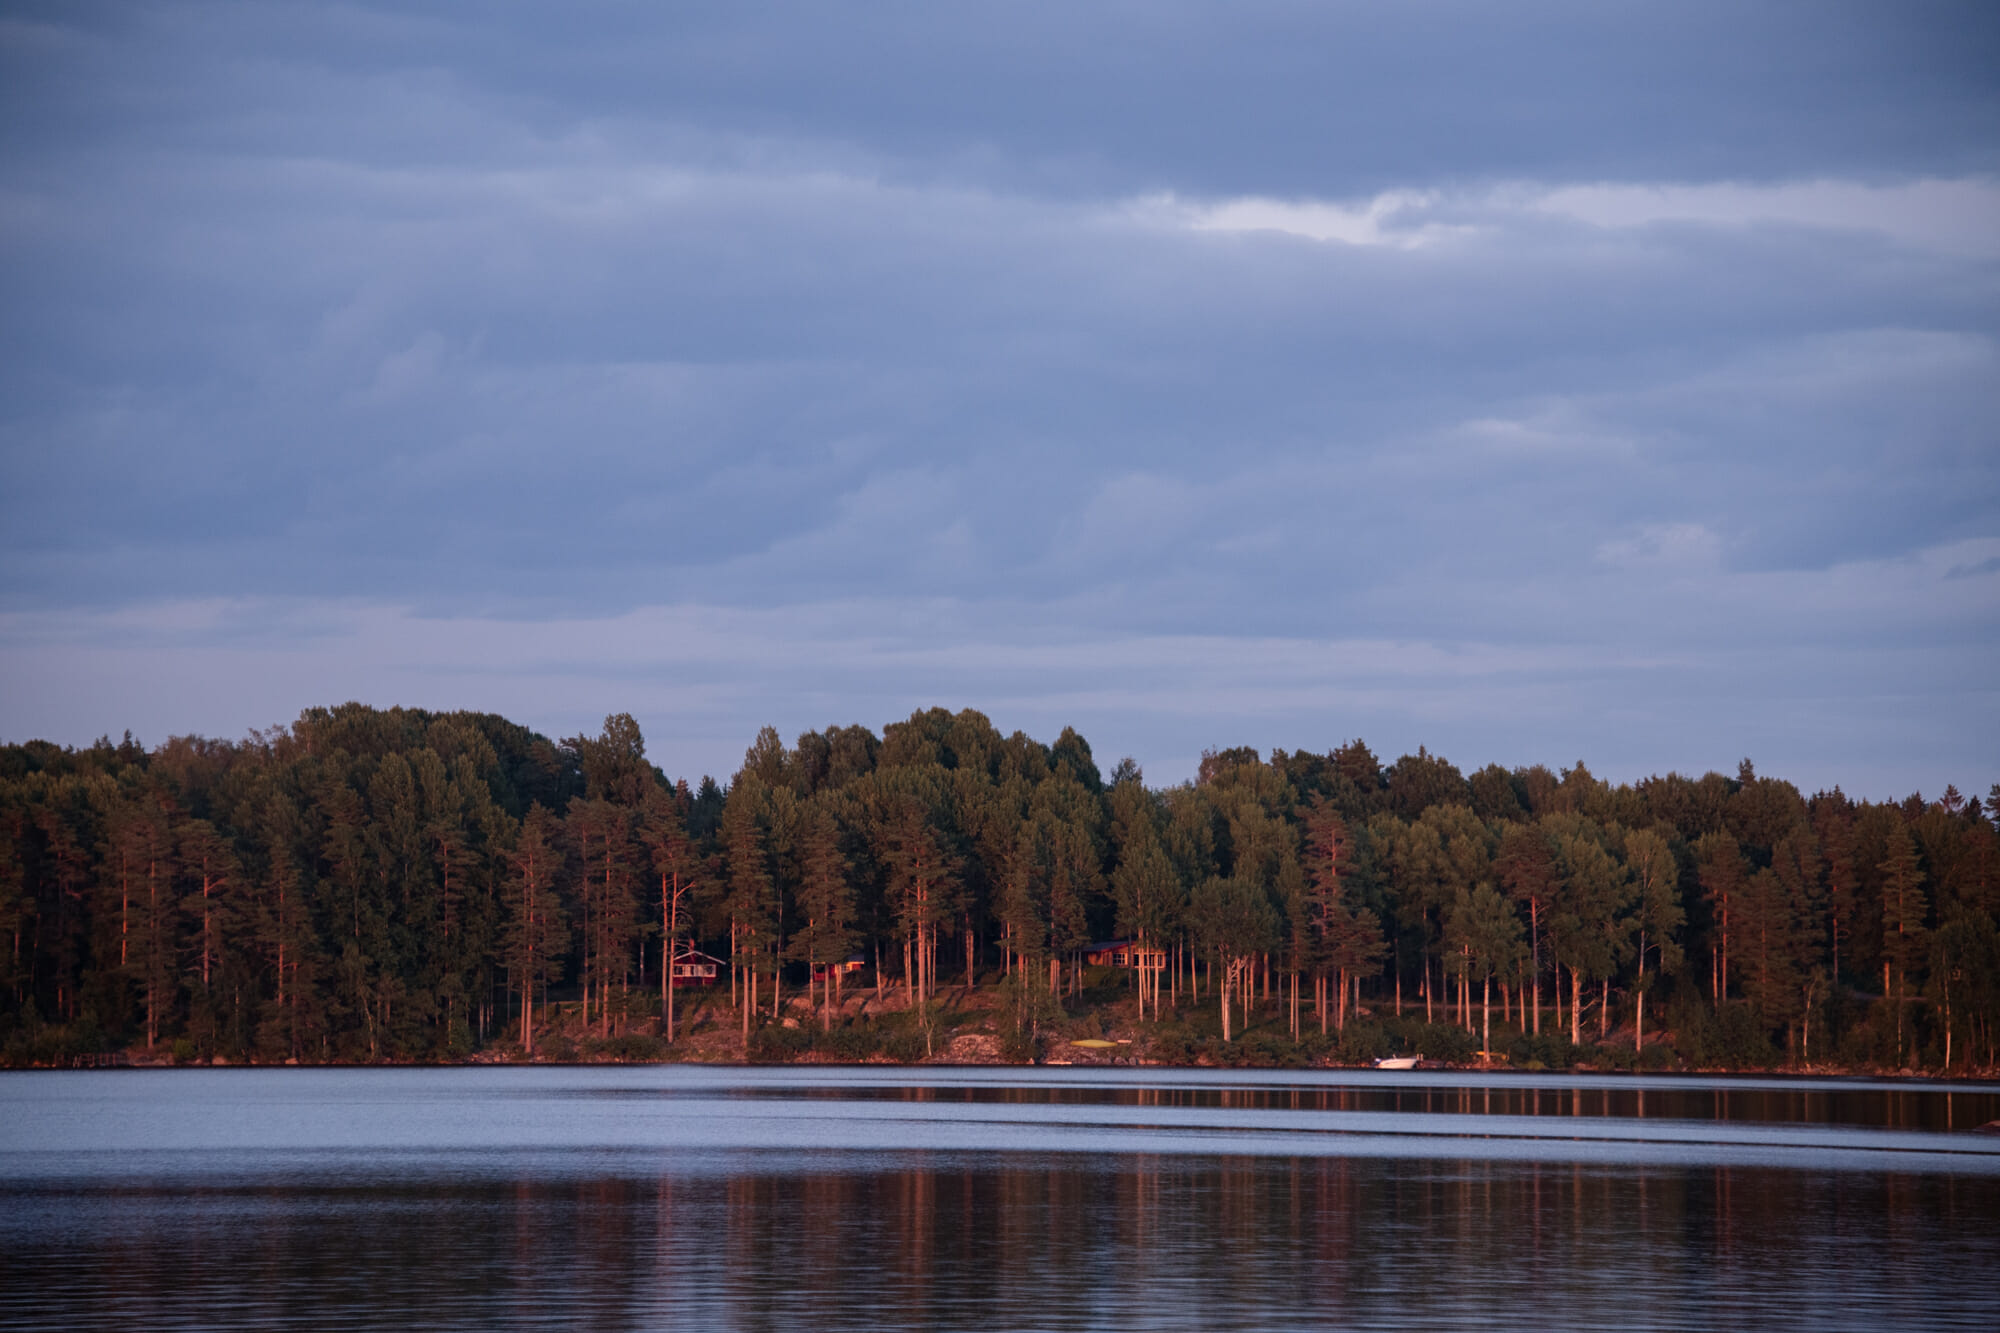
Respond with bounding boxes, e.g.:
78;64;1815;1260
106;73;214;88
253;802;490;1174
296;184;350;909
0;0;2000;797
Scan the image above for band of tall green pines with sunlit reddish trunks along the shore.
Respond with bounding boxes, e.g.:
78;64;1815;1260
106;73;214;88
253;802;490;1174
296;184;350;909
0;705;2000;1069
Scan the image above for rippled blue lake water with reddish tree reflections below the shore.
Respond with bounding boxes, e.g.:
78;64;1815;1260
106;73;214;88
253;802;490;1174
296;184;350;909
0;1067;2000;1333
